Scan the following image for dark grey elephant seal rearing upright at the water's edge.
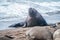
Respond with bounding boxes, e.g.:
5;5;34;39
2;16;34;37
24;8;47;27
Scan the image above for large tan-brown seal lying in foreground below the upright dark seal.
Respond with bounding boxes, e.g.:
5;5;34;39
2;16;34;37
26;27;53;40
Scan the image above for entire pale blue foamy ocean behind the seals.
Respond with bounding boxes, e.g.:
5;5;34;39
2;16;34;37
0;0;60;30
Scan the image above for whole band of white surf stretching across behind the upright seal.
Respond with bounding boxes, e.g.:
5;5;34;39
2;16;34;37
0;1;60;21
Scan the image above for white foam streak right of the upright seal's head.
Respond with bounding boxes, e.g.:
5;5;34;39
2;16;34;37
28;2;60;11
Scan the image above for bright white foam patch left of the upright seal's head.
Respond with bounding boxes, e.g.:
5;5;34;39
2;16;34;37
0;3;29;18
